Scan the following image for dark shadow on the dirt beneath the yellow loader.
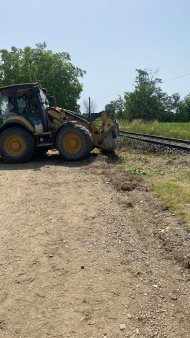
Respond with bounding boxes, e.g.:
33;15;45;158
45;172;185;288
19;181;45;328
0;153;97;172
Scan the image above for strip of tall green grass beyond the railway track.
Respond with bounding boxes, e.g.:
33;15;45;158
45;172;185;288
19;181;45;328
119;120;190;140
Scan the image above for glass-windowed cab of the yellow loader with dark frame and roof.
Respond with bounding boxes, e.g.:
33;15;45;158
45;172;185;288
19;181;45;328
0;83;49;132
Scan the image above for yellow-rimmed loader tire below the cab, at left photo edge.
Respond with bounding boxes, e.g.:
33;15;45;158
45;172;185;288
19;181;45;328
0;127;35;163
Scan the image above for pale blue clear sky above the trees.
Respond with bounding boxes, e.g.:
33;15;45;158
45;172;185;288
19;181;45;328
0;0;190;111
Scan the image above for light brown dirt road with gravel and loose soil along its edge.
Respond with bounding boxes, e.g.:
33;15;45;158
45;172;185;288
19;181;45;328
0;155;190;338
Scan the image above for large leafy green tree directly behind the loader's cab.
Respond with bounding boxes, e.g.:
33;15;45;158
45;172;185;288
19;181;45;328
0;43;85;110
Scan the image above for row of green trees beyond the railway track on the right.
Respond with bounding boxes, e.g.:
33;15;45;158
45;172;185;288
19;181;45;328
105;69;190;122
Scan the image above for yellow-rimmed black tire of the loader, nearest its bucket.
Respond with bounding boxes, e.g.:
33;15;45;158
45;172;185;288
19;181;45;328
56;124;93;161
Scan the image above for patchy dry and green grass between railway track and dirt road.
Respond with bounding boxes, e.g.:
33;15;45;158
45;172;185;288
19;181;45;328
116;140;190;227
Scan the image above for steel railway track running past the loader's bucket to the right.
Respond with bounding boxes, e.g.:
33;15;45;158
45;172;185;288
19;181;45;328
119;130;190;151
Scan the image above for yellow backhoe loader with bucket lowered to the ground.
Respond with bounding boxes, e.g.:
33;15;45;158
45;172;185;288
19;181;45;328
0;83;118;163
